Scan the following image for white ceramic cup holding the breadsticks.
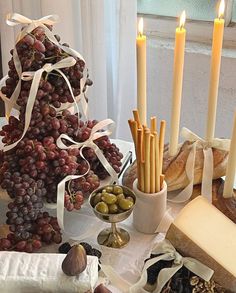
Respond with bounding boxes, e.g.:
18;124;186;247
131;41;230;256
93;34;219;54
133;179;167;234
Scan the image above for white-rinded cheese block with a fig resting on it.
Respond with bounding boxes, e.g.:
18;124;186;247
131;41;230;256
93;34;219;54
0;251;98;293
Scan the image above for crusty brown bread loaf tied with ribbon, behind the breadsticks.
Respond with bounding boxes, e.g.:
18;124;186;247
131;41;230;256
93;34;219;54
123;141;228;191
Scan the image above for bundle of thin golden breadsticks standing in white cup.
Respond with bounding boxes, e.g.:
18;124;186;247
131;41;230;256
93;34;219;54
128;110;166;193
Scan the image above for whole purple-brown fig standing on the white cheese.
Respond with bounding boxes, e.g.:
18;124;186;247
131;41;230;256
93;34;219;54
61;244;87;276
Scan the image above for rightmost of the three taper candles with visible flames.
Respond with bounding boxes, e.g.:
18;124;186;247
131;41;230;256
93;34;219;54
206;0;225;141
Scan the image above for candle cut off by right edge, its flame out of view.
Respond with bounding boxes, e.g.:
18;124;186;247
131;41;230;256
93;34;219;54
223;111;236;198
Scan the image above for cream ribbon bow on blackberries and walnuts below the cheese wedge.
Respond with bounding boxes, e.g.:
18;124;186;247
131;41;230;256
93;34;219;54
101;239;214;293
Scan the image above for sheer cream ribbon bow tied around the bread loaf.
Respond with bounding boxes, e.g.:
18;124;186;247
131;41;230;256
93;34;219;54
168;127;230;203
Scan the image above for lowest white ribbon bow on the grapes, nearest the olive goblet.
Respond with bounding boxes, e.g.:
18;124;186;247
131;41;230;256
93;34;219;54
57;119;118;234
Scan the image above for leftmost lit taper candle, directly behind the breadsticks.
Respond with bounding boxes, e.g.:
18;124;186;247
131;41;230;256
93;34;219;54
136;18;147;125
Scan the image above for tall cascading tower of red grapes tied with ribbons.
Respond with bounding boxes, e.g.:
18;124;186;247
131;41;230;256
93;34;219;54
0;23;122;252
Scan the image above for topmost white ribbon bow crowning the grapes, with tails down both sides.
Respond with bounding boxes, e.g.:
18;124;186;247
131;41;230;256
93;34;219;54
0;13;88;119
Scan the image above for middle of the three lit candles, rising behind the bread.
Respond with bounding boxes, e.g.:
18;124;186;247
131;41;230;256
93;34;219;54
169;11;186;156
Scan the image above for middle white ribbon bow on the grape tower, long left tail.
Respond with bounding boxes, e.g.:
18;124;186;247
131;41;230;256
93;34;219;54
3;57;77;151
